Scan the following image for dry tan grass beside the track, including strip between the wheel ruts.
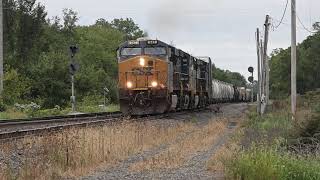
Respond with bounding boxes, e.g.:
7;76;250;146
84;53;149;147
0;109;228;180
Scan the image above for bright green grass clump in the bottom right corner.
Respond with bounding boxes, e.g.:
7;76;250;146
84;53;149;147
228;147;320;180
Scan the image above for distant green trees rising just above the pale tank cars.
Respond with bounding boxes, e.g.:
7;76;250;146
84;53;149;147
212;65;247;87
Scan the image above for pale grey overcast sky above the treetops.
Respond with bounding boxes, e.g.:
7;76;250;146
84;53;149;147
39;0;320;77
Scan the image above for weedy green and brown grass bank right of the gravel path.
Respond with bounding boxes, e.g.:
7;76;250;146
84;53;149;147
208;92;320;180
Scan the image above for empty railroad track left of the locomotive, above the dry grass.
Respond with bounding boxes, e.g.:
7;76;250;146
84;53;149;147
0;112;122;140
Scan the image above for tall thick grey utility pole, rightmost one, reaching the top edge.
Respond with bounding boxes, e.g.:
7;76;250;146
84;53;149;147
291;0;297;120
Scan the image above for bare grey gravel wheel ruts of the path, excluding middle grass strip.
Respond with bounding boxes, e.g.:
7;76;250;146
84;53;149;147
79;103;247;180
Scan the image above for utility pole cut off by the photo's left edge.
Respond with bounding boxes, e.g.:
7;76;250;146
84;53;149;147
0;0;4;96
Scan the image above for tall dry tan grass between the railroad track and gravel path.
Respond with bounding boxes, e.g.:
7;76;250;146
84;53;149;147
0;122;188;180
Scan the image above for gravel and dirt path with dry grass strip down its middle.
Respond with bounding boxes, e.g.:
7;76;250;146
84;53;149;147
80;104;247;180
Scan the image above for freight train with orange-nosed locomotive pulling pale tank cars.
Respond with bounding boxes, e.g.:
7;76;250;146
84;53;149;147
117;38;251;115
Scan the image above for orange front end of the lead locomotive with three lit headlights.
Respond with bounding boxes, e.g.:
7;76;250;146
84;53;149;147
118;39;169;115
